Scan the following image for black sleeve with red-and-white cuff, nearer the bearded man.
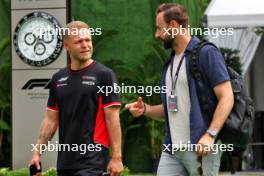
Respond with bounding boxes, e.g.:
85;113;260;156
100;69;121;108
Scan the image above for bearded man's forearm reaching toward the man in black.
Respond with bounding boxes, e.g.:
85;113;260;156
144;104;164;120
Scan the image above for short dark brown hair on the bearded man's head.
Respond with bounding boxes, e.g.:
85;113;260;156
156;3;189;28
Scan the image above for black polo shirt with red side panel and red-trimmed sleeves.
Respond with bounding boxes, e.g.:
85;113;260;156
47;61;120;169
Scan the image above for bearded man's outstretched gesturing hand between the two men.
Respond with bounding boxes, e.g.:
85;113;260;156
125;97;145;117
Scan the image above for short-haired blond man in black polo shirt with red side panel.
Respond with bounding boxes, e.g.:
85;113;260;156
30;21;123;176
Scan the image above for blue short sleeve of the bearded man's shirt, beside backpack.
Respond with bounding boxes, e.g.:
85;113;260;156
199;45;230;88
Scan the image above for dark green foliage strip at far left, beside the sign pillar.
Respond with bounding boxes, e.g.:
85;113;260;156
0;0;11;166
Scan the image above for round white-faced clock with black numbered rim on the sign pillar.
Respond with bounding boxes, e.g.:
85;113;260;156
13;11;63;67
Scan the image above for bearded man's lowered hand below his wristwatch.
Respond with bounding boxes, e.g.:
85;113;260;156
196;133;215;156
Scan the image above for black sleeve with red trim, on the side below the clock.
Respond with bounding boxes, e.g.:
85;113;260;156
47;76;59;111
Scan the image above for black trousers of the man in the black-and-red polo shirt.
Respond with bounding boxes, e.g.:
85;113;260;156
57;168;104;176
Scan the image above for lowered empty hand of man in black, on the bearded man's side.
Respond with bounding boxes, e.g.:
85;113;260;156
107;158;124;176
